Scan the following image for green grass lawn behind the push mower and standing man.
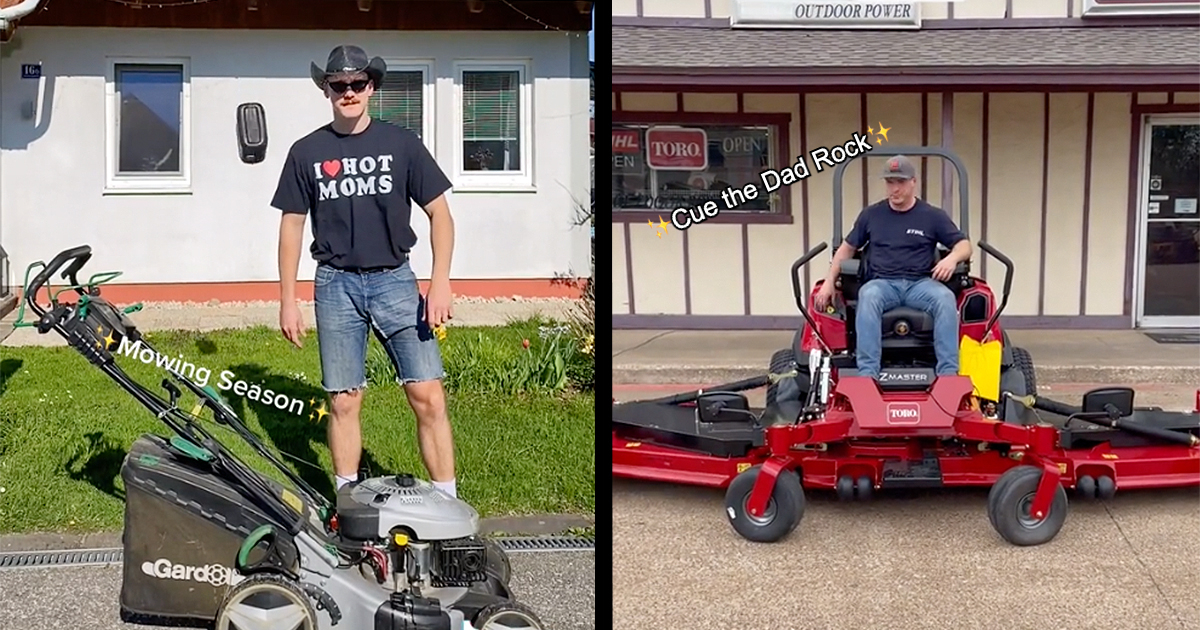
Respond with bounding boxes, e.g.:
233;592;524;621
0;323;595;533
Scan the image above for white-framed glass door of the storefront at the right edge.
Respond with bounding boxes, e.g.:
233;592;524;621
1138;115;1200;328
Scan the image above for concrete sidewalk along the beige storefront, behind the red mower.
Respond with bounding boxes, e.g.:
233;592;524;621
612;330;1200;388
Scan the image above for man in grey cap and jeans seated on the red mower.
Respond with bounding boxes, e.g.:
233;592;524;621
815;155;972;379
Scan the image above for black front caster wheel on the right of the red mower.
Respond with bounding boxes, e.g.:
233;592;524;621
988;466;1067;546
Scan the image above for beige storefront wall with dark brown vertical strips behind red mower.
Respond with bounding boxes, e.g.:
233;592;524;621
613;92;1166;316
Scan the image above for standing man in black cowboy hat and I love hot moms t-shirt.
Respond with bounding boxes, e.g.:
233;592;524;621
271;46;457;496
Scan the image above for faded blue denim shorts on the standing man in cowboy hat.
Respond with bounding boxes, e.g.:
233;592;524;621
313;262;445;392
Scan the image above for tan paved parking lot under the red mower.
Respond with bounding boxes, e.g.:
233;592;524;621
613;385;1200;630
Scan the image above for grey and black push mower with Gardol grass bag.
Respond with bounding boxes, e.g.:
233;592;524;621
18;246;544;630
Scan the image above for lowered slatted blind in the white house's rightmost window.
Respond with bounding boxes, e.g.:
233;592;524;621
462;72;520;142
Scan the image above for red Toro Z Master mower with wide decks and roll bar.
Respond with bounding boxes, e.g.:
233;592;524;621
612;146;1200;545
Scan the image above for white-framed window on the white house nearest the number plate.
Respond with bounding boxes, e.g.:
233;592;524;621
107;60;191;192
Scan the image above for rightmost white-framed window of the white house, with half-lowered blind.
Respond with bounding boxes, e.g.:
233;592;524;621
456;65;532;188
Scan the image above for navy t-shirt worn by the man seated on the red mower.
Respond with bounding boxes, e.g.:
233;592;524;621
846;199;966;280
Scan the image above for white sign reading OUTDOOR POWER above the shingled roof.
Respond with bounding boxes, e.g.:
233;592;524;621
730;0;916;29
